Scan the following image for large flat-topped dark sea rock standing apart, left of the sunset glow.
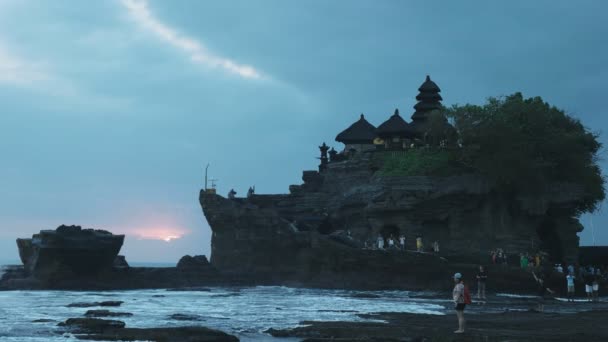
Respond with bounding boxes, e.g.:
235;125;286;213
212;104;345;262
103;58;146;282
17;225;125;278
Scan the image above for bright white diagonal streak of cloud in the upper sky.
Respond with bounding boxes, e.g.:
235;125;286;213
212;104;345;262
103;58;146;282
121;0;262;79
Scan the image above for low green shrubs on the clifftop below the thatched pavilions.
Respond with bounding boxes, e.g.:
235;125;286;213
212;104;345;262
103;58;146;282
381;148;457;176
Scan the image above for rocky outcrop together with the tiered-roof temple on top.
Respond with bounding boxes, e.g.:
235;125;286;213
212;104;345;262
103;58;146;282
199;76;583;286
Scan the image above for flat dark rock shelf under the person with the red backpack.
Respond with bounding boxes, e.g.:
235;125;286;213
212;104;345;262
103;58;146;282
266;311;608;342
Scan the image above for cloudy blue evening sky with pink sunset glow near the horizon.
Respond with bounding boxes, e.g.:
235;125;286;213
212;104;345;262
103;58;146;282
0;0;608;262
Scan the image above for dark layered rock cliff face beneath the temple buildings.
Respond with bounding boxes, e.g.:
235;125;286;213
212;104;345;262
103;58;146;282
200;153;581;286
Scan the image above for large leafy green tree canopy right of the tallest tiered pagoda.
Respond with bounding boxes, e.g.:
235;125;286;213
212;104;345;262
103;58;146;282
446;93;605;214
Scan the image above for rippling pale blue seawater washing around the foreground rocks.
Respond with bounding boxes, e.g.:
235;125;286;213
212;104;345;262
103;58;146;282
0;264;608;342
